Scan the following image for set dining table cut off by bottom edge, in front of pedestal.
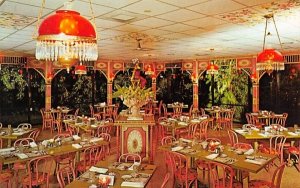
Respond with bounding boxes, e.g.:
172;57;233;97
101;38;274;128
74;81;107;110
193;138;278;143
66;161;156;188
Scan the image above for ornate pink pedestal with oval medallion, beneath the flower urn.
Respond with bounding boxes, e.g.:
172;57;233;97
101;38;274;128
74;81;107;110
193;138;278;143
114;115;155;162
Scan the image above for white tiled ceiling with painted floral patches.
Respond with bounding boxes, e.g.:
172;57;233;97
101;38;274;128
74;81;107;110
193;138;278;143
0;0;300;60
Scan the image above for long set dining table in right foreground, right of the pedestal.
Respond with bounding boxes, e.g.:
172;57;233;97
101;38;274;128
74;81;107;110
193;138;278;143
159;139;277;181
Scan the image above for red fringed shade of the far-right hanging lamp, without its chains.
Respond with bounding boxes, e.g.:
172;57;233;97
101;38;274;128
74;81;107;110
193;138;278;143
256;49;284;74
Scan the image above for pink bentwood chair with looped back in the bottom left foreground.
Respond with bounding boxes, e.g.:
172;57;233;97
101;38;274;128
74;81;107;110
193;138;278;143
21;155;52;188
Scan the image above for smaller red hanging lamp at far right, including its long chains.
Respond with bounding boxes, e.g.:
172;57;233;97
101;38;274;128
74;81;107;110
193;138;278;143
256;14;284;74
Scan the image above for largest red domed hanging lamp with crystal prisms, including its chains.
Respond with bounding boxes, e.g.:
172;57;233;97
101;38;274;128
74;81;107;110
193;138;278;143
35;0;98;71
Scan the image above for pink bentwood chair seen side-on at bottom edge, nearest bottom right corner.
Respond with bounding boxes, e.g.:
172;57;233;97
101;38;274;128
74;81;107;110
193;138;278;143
248;163;286;188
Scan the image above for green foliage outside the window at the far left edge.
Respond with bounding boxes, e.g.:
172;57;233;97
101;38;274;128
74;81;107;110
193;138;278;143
0;66;27;100
